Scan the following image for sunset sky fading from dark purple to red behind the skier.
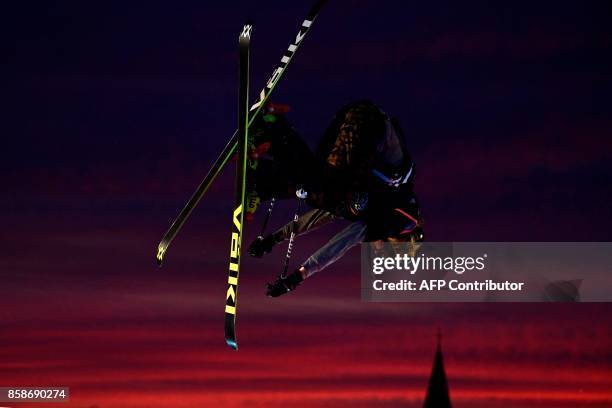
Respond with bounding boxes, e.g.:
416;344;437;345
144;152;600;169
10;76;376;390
0;1;612;407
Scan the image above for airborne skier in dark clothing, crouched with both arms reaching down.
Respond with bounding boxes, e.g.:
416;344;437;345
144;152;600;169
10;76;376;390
249;101;424;297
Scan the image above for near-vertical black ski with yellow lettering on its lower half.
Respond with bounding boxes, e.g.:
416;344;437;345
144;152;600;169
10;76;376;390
225;23;253;350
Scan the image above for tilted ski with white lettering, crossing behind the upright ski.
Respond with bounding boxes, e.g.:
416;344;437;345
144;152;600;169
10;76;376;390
156;0;326;267
